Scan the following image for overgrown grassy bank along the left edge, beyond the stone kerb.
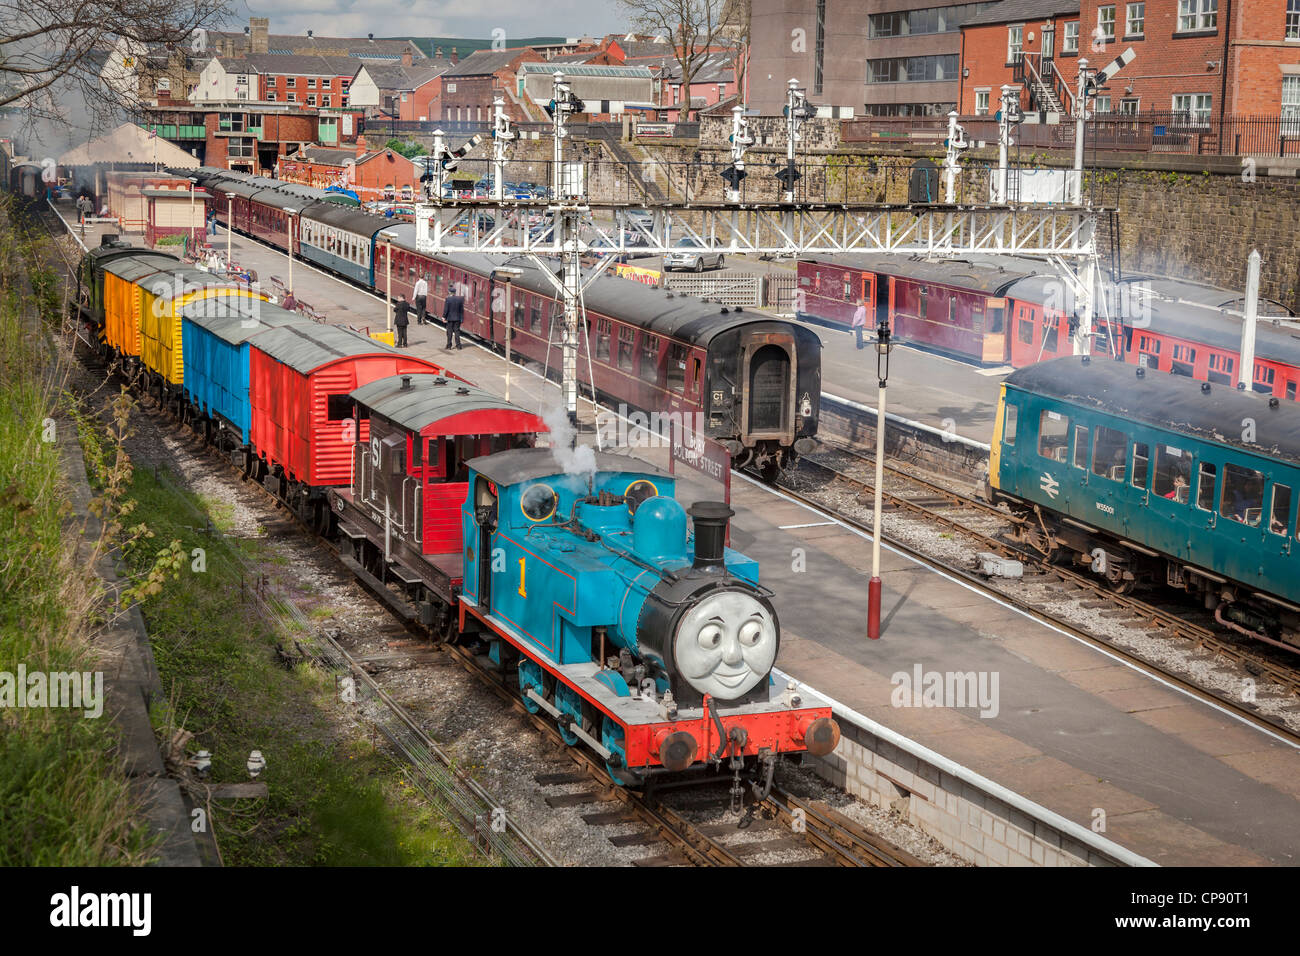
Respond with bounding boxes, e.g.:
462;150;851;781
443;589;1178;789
0;197;150;866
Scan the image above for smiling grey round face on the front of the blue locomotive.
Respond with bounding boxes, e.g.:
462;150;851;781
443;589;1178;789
673;591;776;700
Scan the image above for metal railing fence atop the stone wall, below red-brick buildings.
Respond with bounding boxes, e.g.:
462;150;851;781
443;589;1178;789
840;112;1300;156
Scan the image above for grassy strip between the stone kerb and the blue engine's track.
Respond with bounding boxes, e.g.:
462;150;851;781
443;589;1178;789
127;468;478;866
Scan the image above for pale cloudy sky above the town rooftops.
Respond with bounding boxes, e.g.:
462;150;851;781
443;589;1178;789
237;0;628;46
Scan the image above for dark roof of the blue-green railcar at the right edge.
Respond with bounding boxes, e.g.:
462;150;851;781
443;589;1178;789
1005;356;1300;464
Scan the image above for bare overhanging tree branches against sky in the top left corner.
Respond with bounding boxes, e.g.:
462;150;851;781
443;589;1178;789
0;0;226;132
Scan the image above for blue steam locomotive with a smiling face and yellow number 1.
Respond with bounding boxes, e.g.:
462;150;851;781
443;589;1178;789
460;447;840;787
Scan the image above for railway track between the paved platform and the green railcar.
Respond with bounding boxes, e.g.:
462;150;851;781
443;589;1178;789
781;449;1300;744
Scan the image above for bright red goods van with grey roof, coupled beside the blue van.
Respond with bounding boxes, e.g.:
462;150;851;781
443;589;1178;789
250;324;456;488
